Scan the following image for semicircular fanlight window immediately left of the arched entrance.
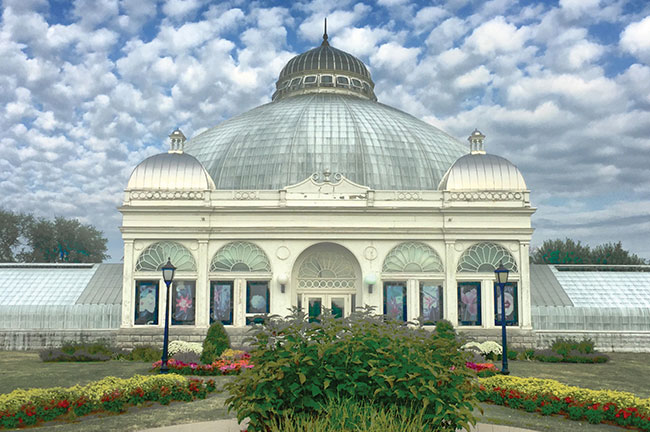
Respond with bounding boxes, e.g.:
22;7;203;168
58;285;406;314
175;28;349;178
210;242;271;273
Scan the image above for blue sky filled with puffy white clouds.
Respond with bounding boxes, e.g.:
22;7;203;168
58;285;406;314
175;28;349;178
0;0;650;262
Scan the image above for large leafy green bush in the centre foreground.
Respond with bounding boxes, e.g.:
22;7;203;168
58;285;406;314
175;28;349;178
226;308;477;431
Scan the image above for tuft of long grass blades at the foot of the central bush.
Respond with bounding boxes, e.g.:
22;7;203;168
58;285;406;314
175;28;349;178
269;399;446;432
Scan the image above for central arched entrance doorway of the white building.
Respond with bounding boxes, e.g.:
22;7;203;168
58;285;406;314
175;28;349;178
292;243;361;320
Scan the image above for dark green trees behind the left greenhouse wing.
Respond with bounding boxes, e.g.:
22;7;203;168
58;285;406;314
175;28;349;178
0;210;109;263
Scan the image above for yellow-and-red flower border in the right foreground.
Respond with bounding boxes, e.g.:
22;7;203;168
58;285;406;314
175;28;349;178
478;375;650;431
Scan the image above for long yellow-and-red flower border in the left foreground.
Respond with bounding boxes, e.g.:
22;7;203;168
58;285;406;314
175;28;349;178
0;375;216;429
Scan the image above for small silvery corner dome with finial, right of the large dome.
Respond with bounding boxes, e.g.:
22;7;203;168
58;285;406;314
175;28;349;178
438;130;528;191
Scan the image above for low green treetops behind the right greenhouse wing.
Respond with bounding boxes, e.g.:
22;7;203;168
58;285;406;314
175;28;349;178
531;238;647;265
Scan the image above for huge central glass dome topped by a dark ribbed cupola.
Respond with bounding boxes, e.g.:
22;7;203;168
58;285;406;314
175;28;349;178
185;35;467;190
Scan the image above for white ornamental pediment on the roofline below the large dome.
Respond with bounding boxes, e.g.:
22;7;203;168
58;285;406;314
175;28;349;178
283;170;370;200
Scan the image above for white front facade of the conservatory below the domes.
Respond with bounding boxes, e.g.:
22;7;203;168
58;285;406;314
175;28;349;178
120;167;534;330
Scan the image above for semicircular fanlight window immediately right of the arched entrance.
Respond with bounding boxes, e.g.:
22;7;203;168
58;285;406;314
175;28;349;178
383;242;443;273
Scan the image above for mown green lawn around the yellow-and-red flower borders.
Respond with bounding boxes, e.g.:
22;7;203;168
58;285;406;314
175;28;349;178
0;351;650;432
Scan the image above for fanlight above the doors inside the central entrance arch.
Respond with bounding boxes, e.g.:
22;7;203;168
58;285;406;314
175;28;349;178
298;251;356;288
